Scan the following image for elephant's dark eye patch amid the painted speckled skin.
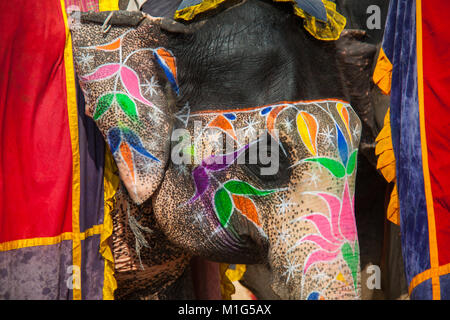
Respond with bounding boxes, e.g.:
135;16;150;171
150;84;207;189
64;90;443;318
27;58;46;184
243;134;292;187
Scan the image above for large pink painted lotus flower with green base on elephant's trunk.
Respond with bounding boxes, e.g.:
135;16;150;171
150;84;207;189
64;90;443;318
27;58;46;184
298;181;359;290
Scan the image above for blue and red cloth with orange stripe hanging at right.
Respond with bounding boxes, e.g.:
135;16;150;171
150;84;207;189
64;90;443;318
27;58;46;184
377;0;450;299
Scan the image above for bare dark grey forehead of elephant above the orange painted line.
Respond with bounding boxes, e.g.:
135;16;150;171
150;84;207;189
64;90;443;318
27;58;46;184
169;1;344;110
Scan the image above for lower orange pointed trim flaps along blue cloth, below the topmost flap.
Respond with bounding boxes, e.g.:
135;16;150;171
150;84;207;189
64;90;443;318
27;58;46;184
375;109;400;225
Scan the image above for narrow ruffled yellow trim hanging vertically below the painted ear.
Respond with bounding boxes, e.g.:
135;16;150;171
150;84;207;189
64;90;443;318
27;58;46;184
100;148;119;300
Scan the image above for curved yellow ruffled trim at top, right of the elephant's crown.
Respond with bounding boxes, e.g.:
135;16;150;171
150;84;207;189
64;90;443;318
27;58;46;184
290;0;347;41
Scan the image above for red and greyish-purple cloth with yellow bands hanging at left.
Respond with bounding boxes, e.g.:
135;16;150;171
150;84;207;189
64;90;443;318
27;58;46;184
0;0;119;299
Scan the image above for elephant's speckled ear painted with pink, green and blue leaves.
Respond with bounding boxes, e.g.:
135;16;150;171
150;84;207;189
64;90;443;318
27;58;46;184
71;11;178;204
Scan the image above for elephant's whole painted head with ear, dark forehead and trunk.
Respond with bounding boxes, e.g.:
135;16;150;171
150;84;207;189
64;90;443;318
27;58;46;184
72;0;362;299
